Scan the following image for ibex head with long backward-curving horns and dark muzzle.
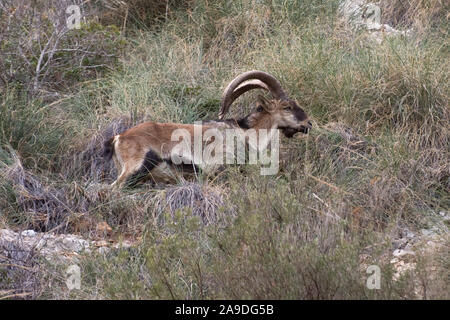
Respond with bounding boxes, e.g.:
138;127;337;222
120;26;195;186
219;70;312;138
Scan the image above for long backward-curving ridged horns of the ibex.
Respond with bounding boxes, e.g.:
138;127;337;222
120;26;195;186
219;70;287;119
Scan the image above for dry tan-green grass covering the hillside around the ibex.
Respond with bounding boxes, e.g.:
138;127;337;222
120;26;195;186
0;0;450;299
